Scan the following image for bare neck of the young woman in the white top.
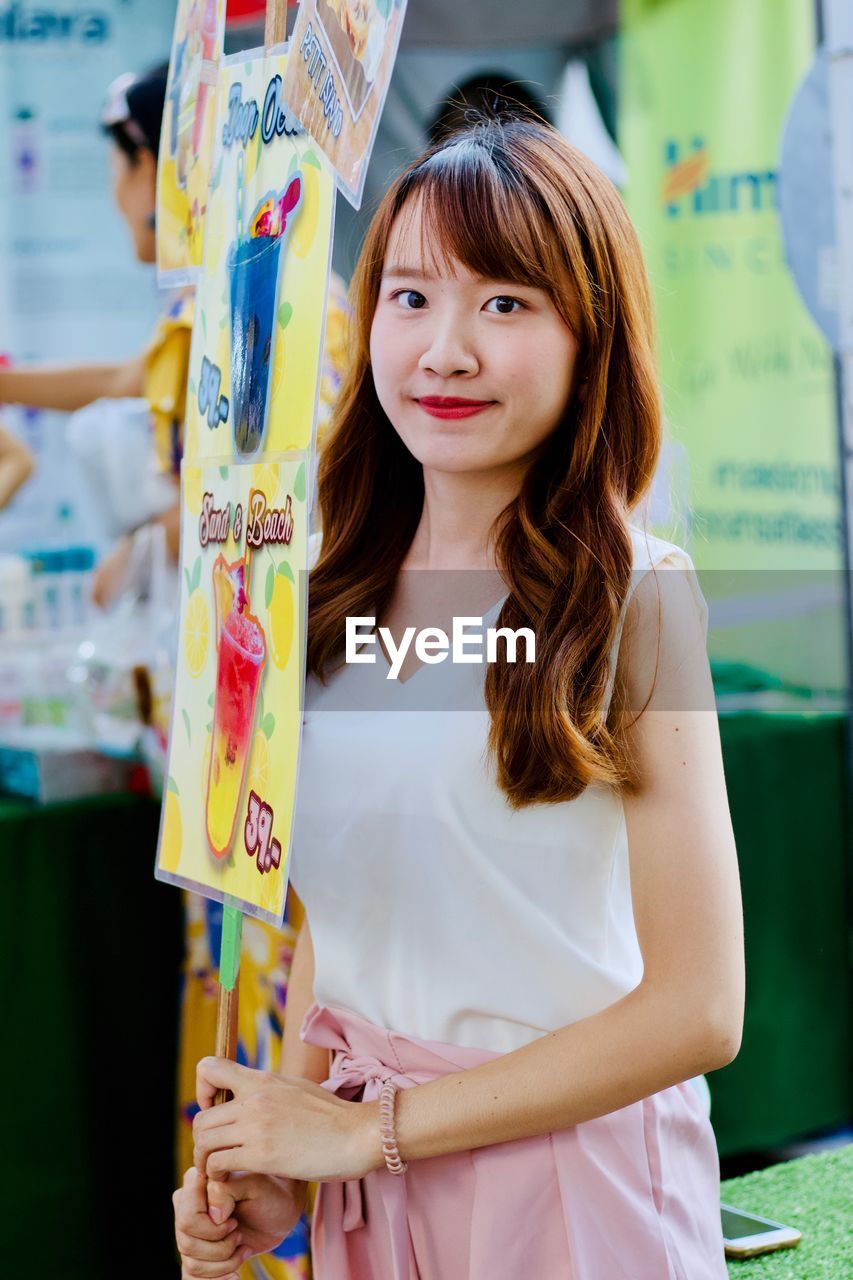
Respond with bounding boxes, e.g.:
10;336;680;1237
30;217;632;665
402;470;521;570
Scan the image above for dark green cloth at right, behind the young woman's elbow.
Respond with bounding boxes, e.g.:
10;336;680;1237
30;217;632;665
708;714;853;1156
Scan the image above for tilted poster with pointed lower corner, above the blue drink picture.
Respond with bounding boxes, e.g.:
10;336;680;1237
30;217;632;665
284;0;406;209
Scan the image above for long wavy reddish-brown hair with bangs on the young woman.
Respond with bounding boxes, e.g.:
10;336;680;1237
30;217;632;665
307;120;661;808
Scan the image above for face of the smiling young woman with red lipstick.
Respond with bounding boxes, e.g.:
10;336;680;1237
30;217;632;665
370;199;578;472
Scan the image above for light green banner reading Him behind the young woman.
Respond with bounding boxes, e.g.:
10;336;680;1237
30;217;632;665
620;0;845;687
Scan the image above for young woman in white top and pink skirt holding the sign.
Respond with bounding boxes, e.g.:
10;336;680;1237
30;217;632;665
174;122;744;1280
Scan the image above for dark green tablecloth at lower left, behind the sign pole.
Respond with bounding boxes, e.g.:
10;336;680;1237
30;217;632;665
0;796;182;1280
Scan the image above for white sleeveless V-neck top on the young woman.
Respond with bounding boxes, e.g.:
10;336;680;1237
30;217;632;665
291;529;704;1052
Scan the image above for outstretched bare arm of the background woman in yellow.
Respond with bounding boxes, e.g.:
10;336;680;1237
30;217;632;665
0;356;145;413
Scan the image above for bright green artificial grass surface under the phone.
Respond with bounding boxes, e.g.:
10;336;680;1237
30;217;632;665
720;1143;853;1280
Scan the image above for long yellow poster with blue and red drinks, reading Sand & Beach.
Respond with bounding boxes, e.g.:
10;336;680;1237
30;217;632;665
156;54;334;923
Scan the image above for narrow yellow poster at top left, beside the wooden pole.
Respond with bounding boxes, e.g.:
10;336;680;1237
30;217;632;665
156;0;225;285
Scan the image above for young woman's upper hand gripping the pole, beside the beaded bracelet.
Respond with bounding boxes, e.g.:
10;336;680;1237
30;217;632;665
192;1057;384;1181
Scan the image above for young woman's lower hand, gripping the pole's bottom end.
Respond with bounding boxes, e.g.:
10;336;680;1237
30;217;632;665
172;1169;307;1280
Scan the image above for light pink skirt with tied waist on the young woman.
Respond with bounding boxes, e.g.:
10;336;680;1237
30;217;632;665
300;1004;727;1280
